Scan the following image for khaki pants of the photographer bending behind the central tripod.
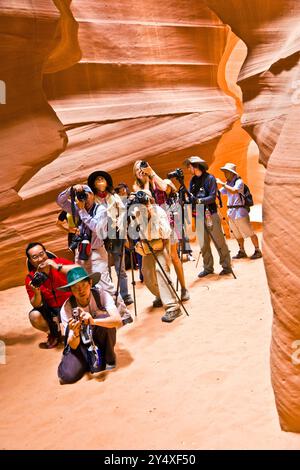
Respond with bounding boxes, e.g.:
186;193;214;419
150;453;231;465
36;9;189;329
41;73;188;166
142;249;178;308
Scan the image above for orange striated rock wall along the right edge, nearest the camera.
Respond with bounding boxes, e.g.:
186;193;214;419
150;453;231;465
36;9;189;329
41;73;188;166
206;0;300;432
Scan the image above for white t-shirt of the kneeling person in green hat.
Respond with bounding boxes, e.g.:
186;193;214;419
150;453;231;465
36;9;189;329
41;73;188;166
60;287;116;332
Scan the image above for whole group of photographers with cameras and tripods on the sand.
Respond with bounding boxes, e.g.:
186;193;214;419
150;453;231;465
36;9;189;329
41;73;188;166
25;156;261;383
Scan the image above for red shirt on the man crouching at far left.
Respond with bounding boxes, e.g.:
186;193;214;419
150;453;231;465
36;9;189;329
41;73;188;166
25;258;74;308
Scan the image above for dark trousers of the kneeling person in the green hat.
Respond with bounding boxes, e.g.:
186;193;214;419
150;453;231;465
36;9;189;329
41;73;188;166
57;326;116;384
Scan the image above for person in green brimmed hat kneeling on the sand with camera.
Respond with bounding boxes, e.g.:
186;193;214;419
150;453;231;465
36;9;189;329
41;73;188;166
58;266;122;384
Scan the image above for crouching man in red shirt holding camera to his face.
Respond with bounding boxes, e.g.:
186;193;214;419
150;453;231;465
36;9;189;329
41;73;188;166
25;242;74;349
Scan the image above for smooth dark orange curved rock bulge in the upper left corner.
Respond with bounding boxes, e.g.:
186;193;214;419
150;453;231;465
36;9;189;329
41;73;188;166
0;0;66;215
